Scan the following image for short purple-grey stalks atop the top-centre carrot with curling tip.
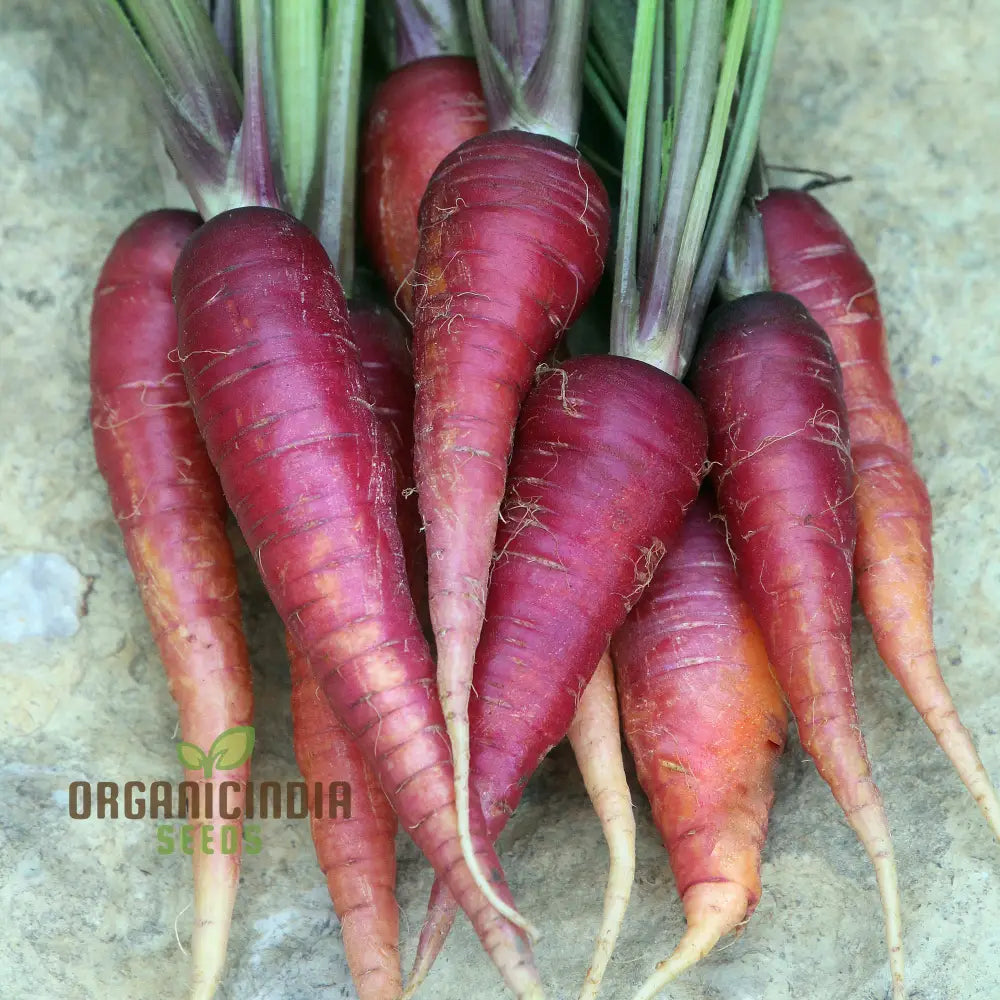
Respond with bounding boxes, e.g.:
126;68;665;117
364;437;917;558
469;0;589;146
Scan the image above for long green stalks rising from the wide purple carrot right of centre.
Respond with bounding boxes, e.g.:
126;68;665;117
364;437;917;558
588;0;782;377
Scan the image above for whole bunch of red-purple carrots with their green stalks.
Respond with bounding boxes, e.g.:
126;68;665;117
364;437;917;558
82;0;1000;1000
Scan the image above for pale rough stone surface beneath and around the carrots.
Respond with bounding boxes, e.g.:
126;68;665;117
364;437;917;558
0;0;1000;1000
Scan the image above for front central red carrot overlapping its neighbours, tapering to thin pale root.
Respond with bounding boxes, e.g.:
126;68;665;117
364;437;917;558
413;131;608;896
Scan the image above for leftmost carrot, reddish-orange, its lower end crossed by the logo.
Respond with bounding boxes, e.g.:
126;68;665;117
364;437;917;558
90;211;253;998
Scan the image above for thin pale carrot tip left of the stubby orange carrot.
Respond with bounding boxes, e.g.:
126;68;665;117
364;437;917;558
566;653;635;1000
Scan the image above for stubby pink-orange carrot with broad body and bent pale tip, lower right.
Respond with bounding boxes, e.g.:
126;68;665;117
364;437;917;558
611;491;788;1000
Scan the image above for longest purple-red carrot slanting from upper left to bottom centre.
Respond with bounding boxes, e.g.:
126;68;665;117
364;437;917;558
174;208;538;996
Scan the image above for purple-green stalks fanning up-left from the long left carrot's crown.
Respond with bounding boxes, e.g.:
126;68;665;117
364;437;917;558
93;0;280;219
